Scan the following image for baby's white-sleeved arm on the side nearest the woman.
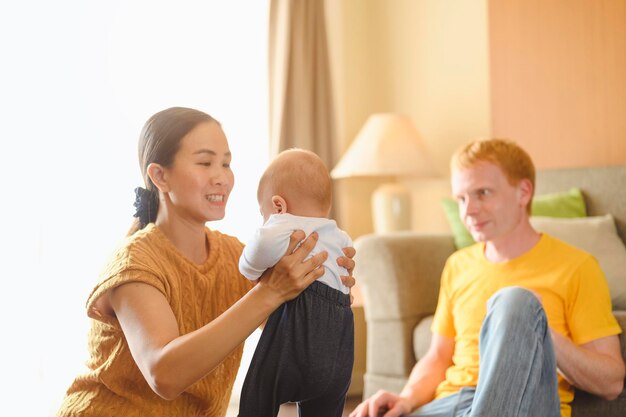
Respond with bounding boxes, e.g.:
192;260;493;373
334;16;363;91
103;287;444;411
239;220;294;280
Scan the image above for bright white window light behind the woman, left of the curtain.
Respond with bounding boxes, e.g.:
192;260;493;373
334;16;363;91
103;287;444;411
0;0;269;416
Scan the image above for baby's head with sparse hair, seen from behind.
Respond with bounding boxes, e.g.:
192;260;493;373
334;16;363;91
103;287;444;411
257;149;332;222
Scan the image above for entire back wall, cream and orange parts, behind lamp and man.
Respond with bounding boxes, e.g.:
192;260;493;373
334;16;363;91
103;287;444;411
327;0;626;237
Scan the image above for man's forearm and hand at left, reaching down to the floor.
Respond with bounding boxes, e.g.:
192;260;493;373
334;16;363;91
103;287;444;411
350;334;454;417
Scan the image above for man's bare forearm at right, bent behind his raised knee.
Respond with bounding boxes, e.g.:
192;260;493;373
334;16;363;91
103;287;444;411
550;330;625;400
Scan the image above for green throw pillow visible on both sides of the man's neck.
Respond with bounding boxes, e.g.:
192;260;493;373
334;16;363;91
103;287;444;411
441;188;587;249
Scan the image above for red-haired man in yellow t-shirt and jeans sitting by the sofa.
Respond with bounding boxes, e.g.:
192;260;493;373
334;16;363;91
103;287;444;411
350;139;625;417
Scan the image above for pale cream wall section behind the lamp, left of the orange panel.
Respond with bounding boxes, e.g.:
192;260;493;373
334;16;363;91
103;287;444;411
327;0;491;237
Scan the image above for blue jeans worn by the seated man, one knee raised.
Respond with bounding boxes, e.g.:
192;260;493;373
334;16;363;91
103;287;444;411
411;287;561;417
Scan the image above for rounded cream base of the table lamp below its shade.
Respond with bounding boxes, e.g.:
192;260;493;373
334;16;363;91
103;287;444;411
372;183;411;233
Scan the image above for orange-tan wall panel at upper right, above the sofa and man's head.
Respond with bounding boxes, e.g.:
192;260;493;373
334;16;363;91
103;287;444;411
489;0;626;168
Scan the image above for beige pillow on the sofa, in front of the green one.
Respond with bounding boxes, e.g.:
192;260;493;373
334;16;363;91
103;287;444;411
530;214;626;310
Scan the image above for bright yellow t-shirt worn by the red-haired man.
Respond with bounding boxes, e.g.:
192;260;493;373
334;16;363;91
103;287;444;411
432;234;621;417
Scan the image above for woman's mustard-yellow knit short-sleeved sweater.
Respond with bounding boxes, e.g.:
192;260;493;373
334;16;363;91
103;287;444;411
57;224;251;417
